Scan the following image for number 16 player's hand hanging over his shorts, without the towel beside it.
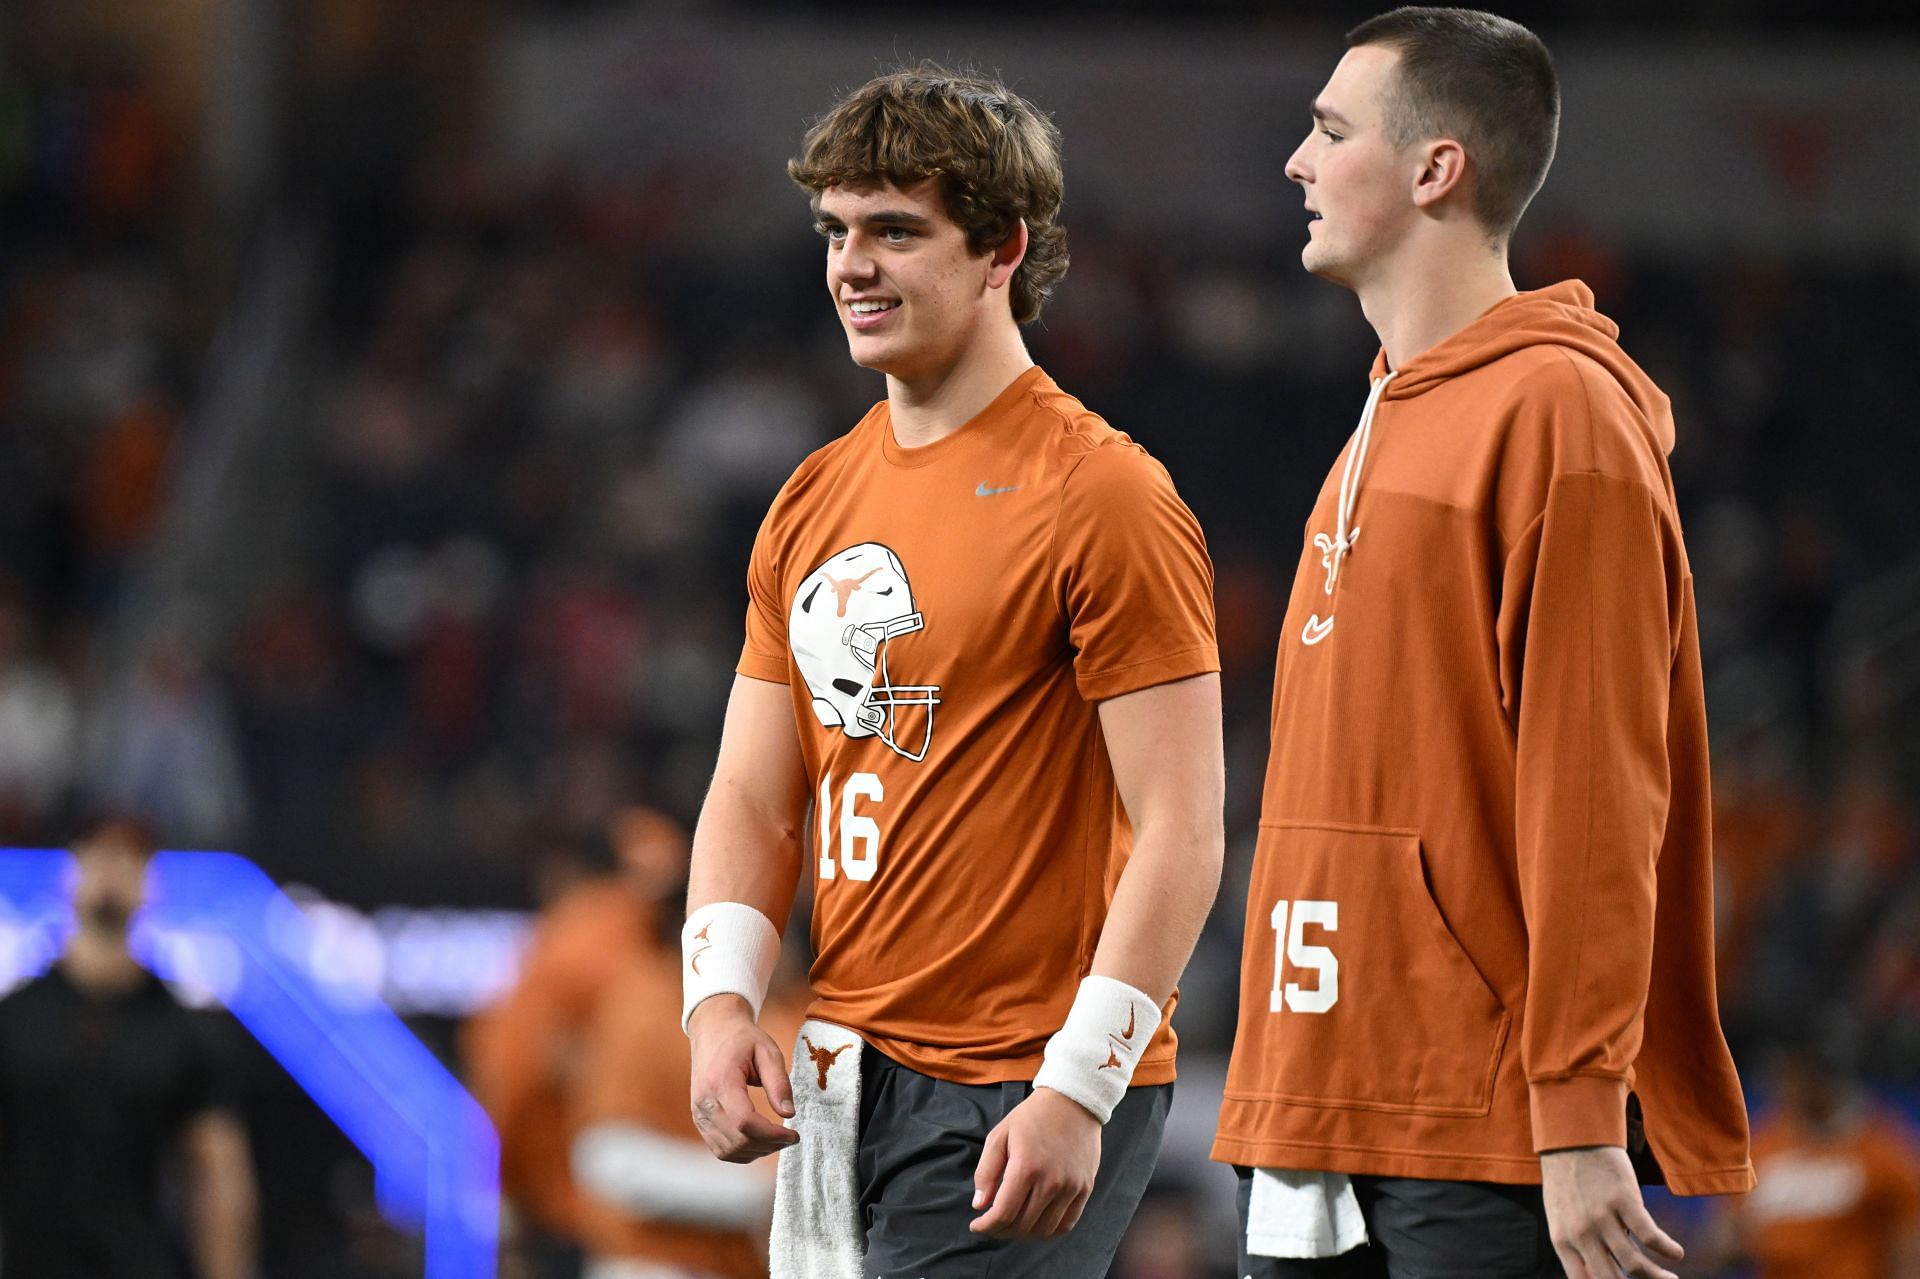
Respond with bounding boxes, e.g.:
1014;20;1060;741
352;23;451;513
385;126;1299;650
968;1089;1100;1239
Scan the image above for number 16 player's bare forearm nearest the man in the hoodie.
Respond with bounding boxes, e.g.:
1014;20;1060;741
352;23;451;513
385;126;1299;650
1092;807;1225;1004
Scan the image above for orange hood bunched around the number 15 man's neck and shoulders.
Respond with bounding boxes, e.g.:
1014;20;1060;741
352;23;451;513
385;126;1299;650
1371;280;1674;455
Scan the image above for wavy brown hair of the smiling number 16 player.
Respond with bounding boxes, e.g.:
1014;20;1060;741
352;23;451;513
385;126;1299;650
787;61;1068;325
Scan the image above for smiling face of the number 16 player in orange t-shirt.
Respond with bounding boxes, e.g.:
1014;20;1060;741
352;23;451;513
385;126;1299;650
816;179;1014;382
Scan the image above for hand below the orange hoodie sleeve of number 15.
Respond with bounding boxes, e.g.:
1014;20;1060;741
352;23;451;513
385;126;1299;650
1540;1146;1686;1279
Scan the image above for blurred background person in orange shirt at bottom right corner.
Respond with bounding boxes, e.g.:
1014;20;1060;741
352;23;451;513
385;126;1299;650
1713;1037;1920;1279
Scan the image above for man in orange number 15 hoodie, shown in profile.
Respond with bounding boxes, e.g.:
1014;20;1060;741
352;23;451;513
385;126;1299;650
1213;8;1753;1279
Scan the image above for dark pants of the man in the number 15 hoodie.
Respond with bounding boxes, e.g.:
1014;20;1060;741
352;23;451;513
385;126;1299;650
1235;1168;1567;1279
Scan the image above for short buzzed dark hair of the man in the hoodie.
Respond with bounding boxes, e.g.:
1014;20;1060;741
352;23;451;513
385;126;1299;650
1346;6;1559;240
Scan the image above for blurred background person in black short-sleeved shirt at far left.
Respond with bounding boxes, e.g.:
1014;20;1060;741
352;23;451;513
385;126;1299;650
0;820;257;1279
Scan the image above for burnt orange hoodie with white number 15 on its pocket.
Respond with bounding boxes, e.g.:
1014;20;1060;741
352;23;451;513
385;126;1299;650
1213;282;1753;1195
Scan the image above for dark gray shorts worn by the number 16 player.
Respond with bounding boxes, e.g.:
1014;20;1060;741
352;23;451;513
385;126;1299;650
858;1047;1173;1279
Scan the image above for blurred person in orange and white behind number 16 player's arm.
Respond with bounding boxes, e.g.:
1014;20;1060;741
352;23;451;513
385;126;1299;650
572;928;804;1279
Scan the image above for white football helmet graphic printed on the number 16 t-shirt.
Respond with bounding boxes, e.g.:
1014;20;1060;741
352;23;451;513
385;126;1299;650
787;542;941;764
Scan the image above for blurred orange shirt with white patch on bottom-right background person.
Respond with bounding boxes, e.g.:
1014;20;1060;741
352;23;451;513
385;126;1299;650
1740;1120;1920;1279
